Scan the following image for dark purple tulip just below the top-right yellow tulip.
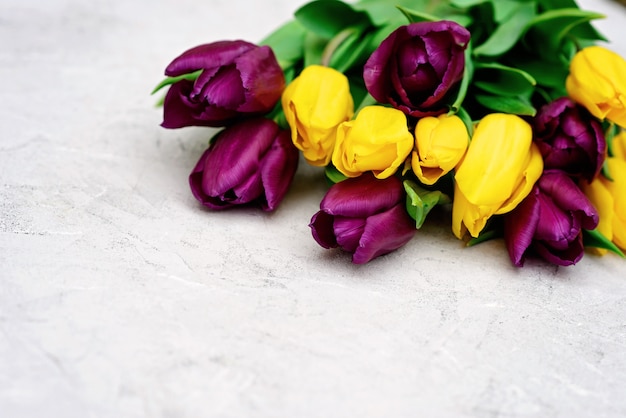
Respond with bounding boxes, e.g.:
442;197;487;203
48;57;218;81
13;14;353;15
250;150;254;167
533;97;607;181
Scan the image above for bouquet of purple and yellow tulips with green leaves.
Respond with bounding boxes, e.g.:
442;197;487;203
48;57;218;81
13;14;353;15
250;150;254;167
155;0;626;266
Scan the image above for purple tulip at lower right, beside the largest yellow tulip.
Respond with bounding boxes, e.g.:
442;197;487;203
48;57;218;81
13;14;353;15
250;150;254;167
504;170;599;267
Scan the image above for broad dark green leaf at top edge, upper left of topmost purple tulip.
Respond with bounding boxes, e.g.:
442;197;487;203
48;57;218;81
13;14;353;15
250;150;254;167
295;0;371;39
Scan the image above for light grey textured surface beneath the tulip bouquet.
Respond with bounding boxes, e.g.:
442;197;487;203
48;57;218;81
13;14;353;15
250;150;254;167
0;0;626;418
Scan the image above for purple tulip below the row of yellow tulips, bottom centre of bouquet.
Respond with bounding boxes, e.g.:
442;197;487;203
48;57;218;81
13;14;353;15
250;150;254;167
309;172;416;264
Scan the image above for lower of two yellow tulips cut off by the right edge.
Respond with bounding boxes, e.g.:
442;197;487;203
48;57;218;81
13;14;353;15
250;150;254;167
580;158;626;254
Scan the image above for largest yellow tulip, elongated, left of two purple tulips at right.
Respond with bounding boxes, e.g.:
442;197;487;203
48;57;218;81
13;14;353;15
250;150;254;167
452;113;543;238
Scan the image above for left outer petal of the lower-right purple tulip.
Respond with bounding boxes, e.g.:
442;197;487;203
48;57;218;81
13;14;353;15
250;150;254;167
504;187;541;267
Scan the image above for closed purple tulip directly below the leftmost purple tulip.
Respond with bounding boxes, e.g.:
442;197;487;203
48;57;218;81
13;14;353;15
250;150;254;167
189;118;299;211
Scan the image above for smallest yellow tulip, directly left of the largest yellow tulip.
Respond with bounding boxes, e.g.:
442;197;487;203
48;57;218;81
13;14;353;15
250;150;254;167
411;115;469;185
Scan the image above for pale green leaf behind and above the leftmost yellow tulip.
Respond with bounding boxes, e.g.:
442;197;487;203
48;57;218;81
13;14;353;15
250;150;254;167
259;20;306;70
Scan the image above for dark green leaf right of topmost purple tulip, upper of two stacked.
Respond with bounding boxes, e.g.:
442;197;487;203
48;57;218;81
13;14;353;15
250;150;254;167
474;62;537;96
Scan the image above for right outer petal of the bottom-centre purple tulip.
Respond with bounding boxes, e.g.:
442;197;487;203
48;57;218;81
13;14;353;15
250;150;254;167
352;204;416;264
